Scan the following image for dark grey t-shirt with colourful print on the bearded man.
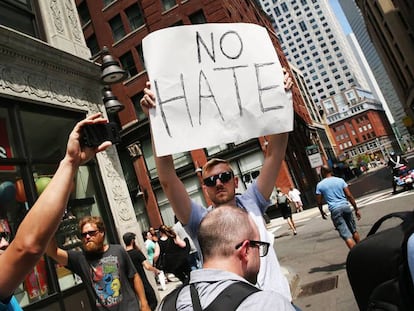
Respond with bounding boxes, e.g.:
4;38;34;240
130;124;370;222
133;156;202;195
67;245;139;311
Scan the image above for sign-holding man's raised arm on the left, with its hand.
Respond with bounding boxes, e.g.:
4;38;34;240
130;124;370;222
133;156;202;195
140;82;191;224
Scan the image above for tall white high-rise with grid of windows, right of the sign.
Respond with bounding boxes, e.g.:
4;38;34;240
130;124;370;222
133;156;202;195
260;0;368;105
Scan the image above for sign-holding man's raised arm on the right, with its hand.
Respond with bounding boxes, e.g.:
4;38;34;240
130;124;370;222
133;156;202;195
257;69;293;199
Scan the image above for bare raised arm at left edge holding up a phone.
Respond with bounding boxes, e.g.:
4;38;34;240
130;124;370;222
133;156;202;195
0;114;111;299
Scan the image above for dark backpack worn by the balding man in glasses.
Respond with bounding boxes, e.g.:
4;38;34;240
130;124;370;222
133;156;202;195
161;281;260;311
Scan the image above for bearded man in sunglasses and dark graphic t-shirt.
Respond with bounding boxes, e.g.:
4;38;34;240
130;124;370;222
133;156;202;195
47;216;151;311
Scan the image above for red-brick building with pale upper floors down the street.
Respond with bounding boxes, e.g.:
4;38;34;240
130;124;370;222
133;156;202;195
322;87;399;164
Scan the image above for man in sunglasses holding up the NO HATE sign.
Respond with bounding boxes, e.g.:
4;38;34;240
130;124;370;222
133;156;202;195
140;73;293;300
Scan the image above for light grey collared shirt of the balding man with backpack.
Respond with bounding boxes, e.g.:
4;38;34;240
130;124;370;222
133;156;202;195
157;269;295;311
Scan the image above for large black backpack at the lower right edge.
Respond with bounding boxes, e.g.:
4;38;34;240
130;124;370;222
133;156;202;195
346;211;414;311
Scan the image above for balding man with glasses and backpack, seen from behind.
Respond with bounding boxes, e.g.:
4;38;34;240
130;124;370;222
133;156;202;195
158;205;294;311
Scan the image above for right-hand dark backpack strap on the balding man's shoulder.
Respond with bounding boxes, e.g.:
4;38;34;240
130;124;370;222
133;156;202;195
204;281;260;311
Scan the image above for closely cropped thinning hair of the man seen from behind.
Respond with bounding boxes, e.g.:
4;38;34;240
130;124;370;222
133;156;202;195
198;205;258;260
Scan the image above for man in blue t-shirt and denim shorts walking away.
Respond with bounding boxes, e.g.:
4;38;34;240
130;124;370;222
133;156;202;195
316;166;361;249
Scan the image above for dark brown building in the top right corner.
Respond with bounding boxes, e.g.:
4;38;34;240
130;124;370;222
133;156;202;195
356;0;414;127
